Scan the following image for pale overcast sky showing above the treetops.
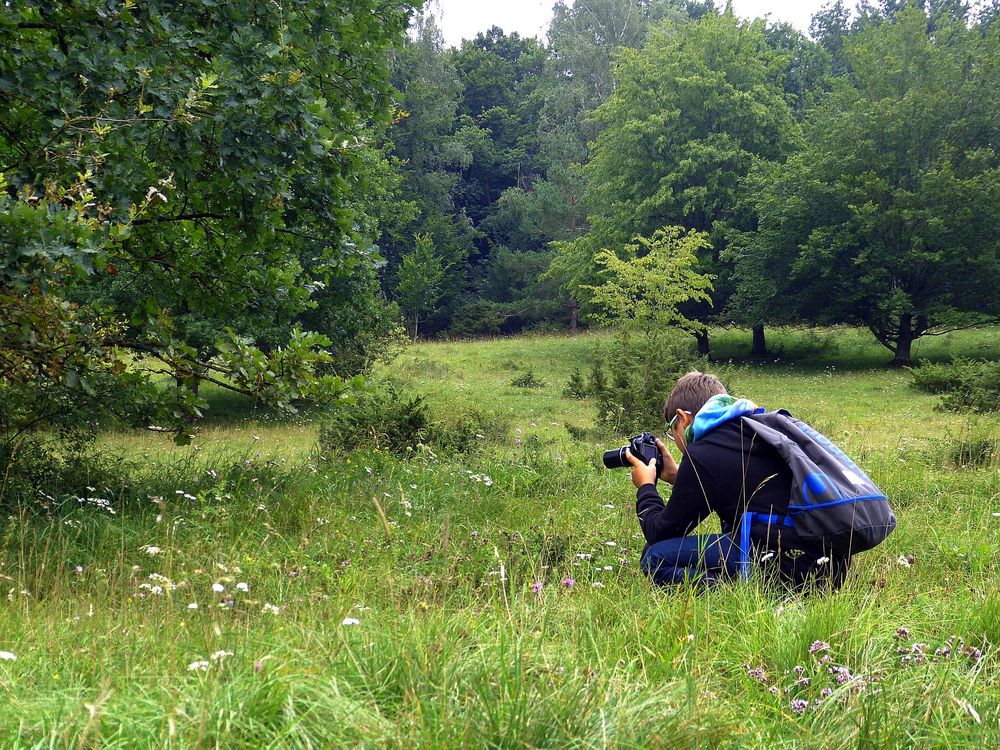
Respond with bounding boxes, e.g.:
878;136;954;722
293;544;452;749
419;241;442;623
427;0;829;46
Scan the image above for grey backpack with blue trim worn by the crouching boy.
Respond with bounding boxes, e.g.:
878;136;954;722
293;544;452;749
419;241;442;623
741;410;896;556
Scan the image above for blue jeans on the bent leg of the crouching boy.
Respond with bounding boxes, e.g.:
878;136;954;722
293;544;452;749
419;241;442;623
639;534;740;586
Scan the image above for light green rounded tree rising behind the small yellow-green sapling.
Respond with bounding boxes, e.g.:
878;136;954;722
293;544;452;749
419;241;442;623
553;8;798;351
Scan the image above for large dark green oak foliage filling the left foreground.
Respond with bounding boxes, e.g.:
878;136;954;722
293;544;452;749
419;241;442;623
0;0;413;440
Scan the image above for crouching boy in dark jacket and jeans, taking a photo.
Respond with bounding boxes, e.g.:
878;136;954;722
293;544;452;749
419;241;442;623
628;372;850;588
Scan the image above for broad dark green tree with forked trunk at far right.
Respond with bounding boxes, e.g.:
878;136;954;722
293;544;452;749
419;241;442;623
733;8;1000;363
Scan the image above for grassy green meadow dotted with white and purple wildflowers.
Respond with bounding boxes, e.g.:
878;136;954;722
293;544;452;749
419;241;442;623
0;329;1000;748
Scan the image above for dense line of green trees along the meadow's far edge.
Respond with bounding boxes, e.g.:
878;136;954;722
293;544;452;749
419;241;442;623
382;0;1000;362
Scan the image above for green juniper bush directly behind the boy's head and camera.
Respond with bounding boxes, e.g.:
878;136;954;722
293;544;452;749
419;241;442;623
591;334;699;434
